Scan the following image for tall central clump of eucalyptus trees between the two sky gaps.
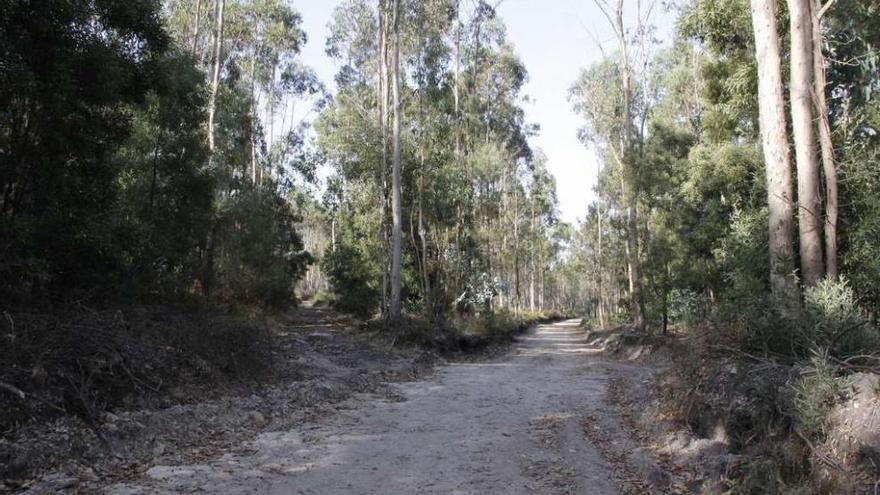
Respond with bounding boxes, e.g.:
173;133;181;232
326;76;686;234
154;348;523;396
318;0;550;319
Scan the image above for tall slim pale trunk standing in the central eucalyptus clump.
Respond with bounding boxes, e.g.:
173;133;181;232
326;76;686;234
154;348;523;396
390;0;403;324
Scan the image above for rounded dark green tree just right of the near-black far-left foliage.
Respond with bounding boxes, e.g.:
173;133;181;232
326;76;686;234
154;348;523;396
115;53;217;299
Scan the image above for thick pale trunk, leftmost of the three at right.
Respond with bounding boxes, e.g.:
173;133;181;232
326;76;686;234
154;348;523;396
751;0;798;304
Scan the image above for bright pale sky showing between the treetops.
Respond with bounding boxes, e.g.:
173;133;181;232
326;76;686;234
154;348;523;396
293;0;671;224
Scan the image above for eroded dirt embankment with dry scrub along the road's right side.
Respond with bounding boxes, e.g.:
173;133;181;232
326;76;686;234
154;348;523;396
588;328;880;494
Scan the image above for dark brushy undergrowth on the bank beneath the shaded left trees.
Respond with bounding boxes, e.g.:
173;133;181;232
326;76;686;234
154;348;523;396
0;307;271;431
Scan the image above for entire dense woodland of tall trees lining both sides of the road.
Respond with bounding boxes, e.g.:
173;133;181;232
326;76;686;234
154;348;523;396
0;0;880;492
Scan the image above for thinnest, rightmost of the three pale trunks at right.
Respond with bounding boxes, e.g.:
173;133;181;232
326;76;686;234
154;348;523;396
811;0;838;278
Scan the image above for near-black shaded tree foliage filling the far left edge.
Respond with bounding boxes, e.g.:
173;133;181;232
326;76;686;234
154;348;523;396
0;1;169;304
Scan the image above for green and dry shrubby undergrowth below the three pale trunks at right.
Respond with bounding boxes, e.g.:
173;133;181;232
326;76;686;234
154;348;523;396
660;280;880;493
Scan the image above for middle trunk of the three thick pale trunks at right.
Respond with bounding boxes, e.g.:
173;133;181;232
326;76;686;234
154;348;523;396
788;0;825;286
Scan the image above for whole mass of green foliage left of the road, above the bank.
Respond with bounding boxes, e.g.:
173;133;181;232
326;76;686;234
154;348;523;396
0;0;320;307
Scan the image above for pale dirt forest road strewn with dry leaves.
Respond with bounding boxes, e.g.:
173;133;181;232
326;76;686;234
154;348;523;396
108;320;618;495
